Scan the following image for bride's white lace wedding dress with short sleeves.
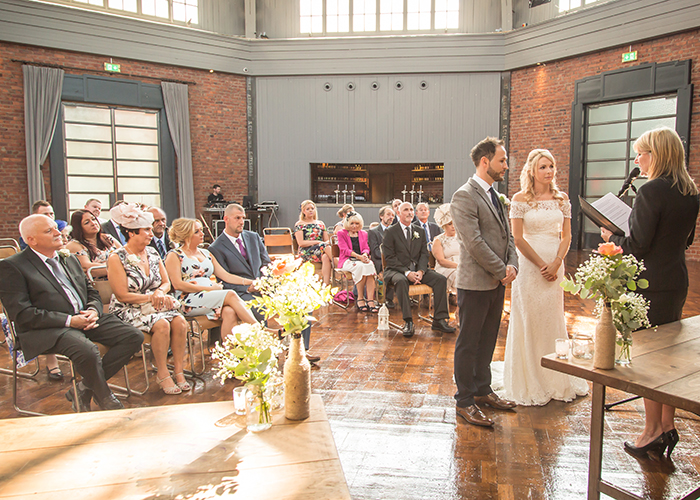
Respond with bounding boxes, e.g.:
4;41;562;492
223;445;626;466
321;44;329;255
503;200;588;406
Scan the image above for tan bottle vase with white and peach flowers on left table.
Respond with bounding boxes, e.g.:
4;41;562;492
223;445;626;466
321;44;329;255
250;259;333;420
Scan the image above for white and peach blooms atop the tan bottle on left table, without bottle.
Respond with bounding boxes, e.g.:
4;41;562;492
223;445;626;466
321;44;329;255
249;259;333;336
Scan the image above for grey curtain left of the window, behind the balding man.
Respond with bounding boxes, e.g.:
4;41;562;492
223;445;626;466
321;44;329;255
22;64;64;209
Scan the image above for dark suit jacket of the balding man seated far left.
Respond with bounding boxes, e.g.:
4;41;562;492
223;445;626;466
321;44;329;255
0;248;102;359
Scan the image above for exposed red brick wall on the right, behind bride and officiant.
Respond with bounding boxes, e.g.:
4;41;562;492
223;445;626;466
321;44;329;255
508;26;700;260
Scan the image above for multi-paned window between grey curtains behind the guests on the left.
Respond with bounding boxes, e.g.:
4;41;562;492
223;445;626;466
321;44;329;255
63;103;161;217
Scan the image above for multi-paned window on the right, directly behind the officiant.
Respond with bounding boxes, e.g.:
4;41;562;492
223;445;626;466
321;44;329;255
583;95;676;238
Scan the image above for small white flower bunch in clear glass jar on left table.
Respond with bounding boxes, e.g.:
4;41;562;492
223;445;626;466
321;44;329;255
212;323;282;430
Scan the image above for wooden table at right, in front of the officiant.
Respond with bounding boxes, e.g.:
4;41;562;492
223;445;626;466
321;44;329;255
542;316;700;500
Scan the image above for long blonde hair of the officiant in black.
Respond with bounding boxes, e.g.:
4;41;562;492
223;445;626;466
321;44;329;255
633;127;698;196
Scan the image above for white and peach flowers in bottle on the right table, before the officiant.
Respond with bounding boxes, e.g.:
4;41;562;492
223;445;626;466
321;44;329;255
561;242;651;368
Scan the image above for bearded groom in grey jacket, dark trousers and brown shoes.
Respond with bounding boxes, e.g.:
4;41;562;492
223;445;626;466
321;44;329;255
450;137;518;427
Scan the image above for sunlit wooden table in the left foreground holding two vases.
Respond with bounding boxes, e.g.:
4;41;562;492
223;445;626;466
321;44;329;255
0;395;350;500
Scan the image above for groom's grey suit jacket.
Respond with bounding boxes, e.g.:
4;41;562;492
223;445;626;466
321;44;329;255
450;178;518;290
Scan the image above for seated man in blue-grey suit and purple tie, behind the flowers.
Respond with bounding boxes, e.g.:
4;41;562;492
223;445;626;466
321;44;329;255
209;203;270;308
